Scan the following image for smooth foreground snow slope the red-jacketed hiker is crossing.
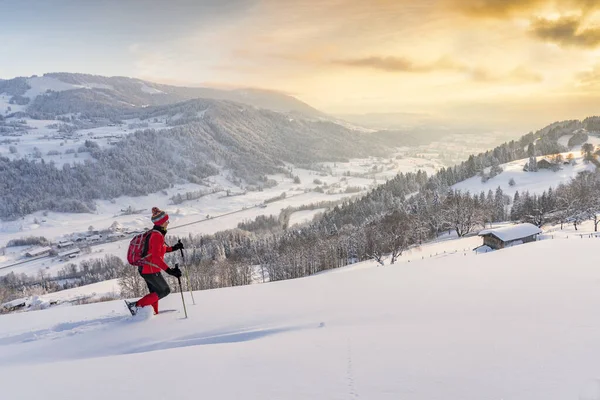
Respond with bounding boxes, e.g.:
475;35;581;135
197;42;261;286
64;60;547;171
0;240;600;400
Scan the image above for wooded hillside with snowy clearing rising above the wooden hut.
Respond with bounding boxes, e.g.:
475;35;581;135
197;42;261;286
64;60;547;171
320;117;600;233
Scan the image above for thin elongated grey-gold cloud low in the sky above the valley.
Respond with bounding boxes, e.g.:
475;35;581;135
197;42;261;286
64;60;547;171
333;56;466;73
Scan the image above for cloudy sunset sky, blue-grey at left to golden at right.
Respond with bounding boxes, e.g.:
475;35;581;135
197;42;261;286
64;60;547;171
0;0;600;125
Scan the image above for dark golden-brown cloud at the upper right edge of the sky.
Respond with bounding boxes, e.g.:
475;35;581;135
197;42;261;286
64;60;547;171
531;17;600;48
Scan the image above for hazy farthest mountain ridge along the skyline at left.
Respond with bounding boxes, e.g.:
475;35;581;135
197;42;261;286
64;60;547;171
0;73;324;118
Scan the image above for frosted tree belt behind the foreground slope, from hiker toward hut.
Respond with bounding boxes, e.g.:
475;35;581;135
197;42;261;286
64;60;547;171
155;189;510;290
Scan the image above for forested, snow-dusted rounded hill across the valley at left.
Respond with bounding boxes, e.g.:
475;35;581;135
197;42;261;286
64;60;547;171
0;97;387;219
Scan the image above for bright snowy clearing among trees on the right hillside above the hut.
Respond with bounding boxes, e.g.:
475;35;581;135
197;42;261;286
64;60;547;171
452;152;596;196
